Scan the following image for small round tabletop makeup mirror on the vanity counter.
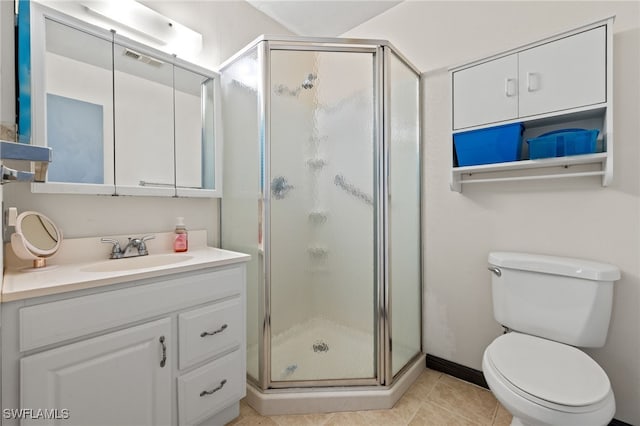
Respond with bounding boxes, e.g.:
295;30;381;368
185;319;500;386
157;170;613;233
11;211;62;268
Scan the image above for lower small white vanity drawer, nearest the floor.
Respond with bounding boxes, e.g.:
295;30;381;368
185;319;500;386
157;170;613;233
178;351;245;425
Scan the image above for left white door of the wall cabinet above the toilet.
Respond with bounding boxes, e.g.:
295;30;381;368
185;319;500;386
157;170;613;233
453;54;518;129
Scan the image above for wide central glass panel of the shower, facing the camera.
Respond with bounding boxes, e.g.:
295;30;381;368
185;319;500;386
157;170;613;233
267;50;377;382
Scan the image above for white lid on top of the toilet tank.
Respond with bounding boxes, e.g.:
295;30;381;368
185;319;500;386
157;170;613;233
489;251;620;281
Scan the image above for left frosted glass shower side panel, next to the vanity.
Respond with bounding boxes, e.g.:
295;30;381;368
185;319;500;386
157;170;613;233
220;48;264;381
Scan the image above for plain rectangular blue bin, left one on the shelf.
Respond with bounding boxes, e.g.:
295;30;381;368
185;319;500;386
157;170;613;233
453;123;524;166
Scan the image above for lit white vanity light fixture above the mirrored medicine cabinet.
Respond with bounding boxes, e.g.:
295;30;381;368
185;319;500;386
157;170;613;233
81;0;202;57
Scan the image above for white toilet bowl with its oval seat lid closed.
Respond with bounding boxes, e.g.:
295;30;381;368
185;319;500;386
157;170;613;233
482;332;615;426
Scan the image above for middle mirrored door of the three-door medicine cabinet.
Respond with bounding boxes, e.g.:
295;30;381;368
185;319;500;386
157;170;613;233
113;44;175;196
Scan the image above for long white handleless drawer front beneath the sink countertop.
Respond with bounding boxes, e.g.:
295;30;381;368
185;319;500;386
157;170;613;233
19;266;244;351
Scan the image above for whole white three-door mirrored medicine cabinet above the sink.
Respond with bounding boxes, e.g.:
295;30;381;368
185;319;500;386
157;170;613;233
24;2;222;197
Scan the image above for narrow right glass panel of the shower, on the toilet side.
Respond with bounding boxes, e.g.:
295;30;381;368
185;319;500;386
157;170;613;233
385;49;422;376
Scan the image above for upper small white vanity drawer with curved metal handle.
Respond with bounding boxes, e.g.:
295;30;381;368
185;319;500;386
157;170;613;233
178;297;244;369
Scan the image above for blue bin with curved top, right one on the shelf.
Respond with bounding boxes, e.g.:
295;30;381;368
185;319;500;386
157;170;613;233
527;129;600;160
